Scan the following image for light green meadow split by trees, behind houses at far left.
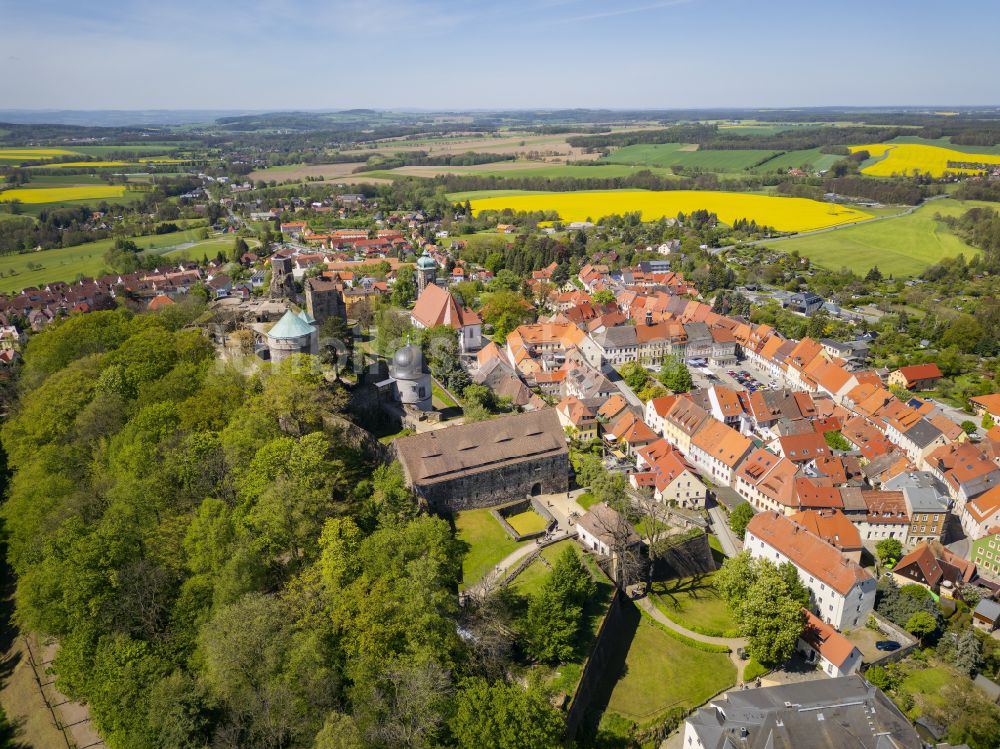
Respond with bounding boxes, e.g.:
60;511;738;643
0;229;219;292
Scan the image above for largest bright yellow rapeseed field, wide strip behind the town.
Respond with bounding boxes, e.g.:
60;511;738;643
471;190;871;231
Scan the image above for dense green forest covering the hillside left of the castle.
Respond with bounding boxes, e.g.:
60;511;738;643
2;302;594;749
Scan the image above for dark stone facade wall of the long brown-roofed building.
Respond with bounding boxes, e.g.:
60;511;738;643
414;452;569;512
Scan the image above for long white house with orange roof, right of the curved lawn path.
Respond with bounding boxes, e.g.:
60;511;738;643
743;512;875;630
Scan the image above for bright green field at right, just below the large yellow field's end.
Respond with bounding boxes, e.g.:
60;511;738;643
773;198;984;276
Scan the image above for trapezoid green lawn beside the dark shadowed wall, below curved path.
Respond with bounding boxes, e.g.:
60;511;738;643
607;615;736;725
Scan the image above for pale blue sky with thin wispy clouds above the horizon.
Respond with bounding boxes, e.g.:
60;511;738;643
0;0;1000;110
